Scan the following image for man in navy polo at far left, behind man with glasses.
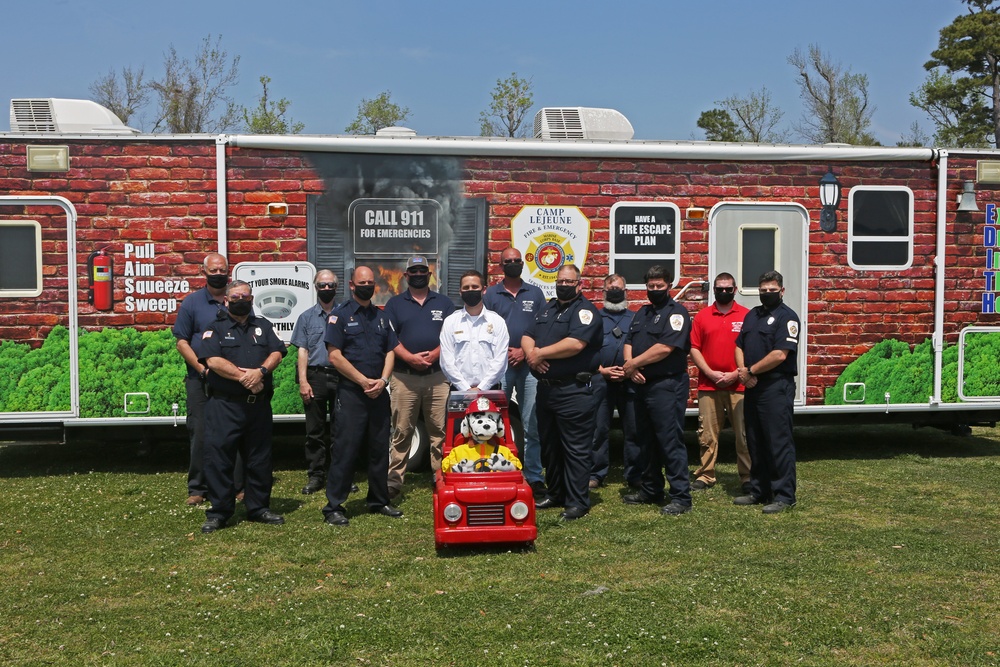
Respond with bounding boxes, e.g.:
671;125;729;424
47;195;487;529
173;252;243;505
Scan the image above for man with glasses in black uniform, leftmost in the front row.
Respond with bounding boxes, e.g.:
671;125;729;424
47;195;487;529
201;280;286;533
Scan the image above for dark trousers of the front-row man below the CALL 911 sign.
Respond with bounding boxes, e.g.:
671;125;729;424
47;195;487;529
323;380;390;515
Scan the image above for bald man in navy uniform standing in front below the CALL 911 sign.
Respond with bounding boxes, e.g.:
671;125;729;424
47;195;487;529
323;266;403;526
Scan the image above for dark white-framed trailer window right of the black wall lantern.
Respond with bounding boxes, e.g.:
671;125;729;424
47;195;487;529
847;185;913;271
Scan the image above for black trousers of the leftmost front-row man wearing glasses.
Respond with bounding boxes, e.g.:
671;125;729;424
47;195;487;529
205;395;274;520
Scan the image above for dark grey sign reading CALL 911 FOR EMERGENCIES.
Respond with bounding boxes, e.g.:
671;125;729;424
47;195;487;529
347;198;441;257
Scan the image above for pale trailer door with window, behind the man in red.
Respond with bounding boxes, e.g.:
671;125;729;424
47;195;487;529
708;202;809;405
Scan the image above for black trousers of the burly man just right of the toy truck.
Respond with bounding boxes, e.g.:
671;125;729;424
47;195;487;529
535;382;595;510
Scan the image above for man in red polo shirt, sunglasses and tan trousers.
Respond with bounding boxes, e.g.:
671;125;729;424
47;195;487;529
691;273;750;492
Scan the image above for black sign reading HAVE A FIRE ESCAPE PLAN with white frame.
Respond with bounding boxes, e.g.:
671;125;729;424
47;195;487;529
609;202;681;289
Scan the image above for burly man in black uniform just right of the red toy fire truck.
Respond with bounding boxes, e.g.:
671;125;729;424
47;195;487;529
521;264;604;521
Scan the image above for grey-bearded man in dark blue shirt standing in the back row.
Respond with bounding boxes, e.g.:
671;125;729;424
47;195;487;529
590;273;645;489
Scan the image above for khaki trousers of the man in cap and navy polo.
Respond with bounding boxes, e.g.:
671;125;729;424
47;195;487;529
389;371;451;491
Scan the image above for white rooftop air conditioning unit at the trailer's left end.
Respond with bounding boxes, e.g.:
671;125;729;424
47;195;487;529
10;97;139;134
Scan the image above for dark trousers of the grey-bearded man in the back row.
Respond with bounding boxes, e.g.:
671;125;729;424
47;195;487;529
590;373;646;486
